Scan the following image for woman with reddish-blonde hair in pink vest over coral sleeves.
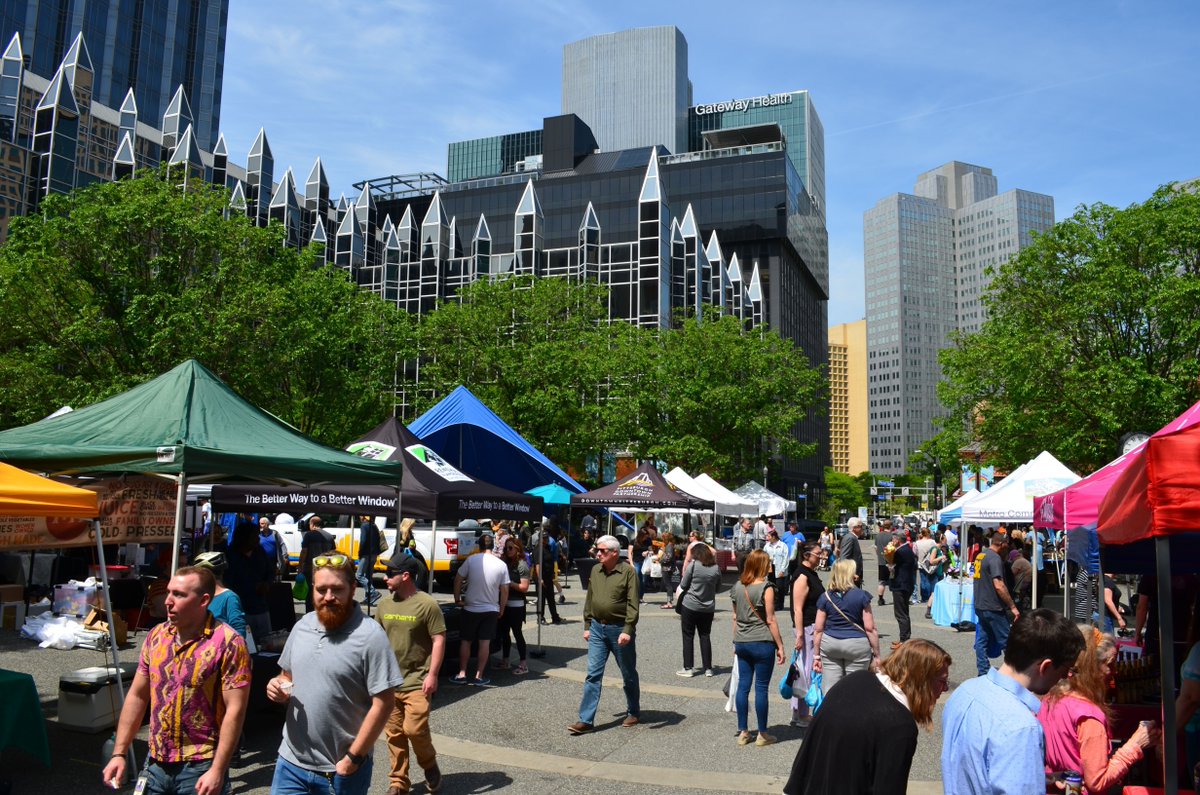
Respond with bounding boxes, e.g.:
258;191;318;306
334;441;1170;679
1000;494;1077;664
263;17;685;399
1038;627;1162;793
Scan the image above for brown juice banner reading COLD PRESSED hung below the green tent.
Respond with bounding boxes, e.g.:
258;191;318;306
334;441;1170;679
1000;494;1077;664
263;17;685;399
0;477;176;551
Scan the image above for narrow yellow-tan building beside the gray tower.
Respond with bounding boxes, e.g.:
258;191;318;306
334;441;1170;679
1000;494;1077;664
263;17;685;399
829;319;870;476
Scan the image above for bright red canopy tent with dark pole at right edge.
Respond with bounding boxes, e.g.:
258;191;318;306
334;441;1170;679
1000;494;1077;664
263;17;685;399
1097;402;1200;795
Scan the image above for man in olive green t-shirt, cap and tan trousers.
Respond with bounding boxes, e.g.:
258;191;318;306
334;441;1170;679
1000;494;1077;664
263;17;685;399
377;550;446;795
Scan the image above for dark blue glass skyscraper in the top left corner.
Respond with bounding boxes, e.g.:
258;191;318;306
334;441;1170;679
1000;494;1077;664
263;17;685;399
0;0;229;150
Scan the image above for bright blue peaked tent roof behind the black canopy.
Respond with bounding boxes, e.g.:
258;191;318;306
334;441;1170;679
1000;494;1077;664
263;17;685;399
408;387;587;494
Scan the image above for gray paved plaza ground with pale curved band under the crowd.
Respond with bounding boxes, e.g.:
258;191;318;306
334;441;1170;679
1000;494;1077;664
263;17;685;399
0;543;974;795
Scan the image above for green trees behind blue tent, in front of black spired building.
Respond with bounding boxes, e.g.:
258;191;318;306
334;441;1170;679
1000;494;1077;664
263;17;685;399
414;277;824;482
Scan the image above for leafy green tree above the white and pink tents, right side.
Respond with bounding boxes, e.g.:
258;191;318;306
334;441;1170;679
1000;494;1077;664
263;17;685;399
940;185;1200;472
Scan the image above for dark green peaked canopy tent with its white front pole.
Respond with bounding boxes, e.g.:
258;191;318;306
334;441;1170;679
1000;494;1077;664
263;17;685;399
0;359;403;570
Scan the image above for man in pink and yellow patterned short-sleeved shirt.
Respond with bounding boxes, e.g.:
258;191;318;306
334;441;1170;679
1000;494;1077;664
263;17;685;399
103;566;250;795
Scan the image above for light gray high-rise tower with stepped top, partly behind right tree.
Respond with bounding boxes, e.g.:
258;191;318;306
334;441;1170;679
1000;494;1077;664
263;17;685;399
863;161;1054;474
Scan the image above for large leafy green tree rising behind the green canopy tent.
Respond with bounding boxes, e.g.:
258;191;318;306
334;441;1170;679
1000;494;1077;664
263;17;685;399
0;172;407;444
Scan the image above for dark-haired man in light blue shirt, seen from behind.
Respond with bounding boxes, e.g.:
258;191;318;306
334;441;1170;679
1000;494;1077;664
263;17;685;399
942;609;1084;795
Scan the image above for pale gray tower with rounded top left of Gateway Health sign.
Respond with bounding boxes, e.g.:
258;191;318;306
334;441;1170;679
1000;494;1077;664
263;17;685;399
563;25;691;154
